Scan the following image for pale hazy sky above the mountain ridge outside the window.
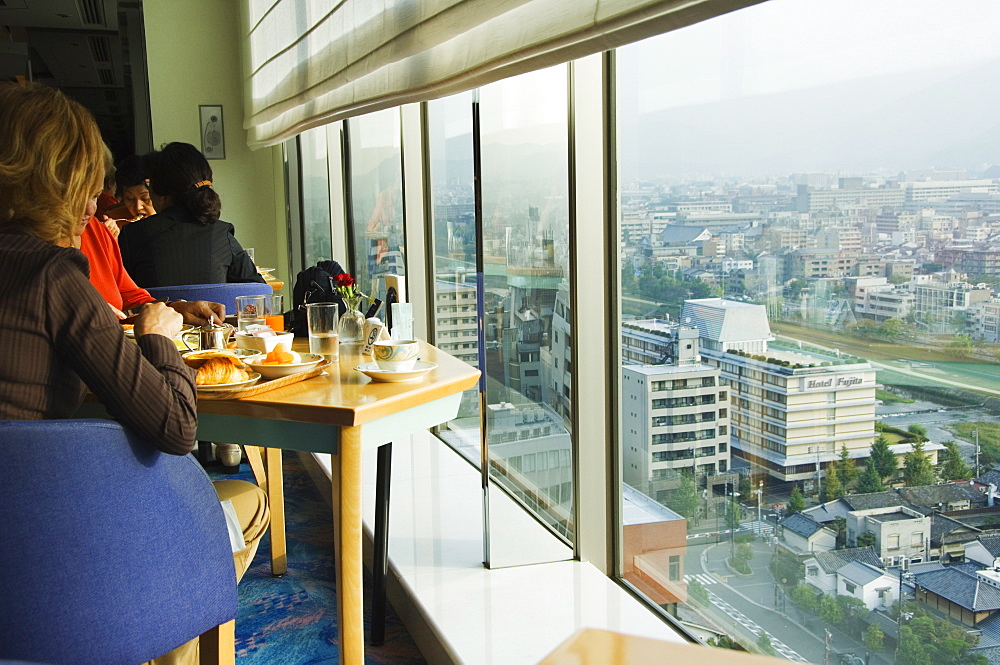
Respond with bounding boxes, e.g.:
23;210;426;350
619;0;1000;113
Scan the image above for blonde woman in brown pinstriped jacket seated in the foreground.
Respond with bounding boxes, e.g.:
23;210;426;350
0;83;268;663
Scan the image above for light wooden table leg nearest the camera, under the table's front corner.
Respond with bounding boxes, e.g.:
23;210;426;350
330;427;365;665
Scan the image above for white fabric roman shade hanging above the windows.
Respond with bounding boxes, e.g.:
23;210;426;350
242;0;761;147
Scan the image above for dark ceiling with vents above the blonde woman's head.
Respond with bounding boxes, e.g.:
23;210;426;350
0;0;151;159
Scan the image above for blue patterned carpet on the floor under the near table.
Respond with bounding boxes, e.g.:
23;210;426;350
208;451;426;665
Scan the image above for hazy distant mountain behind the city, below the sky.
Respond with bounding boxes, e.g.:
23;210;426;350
619;60;1000;180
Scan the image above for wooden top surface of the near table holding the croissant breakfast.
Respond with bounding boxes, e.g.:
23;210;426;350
198;338;479;426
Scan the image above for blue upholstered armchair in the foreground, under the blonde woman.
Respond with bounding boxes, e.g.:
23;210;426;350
0;420;236;665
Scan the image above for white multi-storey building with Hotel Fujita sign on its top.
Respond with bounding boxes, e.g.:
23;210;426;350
682;298;876;481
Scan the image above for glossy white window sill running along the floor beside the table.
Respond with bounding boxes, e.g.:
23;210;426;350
300;433;687;665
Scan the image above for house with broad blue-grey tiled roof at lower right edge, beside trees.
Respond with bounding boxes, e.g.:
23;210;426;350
913;566;1000;626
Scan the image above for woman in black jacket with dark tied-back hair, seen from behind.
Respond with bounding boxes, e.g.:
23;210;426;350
118;143;264;288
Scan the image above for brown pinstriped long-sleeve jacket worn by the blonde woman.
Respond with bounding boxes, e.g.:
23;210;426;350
0;232;198;455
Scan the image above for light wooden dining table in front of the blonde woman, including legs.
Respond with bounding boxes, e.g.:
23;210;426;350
81;339;480;665
